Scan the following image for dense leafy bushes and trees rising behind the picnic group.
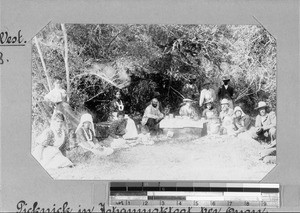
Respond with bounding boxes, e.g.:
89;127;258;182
32;23;276;132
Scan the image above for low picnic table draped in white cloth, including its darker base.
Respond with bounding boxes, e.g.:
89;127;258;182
159;116;206;137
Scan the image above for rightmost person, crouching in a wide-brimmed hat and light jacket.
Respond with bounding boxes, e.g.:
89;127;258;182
252;101;276;141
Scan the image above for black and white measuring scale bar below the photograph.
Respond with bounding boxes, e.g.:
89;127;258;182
109;182;280;208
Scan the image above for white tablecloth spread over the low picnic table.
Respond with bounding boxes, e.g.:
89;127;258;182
159;118;205;129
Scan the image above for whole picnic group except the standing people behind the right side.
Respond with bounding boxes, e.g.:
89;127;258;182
34;77;276;168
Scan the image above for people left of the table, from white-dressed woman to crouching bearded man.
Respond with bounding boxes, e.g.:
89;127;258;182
33;80;168;168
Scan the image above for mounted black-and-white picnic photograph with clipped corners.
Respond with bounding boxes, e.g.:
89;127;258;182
31;23;277;181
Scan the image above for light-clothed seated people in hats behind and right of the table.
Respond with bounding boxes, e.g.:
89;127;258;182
179;98;276;142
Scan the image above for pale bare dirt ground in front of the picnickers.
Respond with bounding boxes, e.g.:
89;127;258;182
48;135;275;181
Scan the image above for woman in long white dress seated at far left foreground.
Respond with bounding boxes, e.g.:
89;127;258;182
33;112;73;169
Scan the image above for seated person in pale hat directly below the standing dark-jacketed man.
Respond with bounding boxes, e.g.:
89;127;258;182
220;98;234;135
